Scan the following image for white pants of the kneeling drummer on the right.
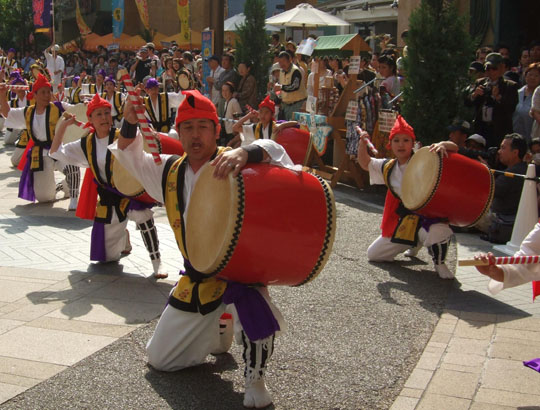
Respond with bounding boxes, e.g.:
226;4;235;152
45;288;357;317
368;223;453;262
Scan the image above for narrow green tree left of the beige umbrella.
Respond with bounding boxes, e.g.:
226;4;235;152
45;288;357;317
235;0;272;96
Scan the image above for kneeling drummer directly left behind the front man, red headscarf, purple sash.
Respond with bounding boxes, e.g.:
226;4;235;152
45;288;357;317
49;94;167;279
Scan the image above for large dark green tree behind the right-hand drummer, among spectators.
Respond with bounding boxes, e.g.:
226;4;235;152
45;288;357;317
402;0;473;145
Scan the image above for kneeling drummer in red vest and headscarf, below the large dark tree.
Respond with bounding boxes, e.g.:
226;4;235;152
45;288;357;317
358;115;454;279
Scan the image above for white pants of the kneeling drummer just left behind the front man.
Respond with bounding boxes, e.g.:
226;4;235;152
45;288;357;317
105;209;154;262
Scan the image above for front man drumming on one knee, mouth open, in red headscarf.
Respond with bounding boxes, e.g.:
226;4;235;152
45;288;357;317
109;90;292;408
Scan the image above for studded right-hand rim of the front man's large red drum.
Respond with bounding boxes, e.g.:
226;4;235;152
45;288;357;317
291;173;336;287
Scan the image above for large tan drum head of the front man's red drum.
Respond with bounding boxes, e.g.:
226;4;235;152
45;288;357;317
186;164;243;273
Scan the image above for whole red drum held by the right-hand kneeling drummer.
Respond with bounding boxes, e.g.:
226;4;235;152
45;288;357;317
401;147;495;226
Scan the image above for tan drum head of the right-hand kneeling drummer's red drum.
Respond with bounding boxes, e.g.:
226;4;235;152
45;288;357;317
401;147;442;211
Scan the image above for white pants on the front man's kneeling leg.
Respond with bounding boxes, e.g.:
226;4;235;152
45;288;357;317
146;304;225;372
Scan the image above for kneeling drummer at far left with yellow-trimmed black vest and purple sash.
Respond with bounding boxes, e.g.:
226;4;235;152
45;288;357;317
0;74;80;210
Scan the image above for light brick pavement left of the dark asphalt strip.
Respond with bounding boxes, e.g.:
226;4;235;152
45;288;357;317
0;137;183;403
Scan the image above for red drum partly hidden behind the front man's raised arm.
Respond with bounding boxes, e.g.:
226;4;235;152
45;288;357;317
113;132;184;204
